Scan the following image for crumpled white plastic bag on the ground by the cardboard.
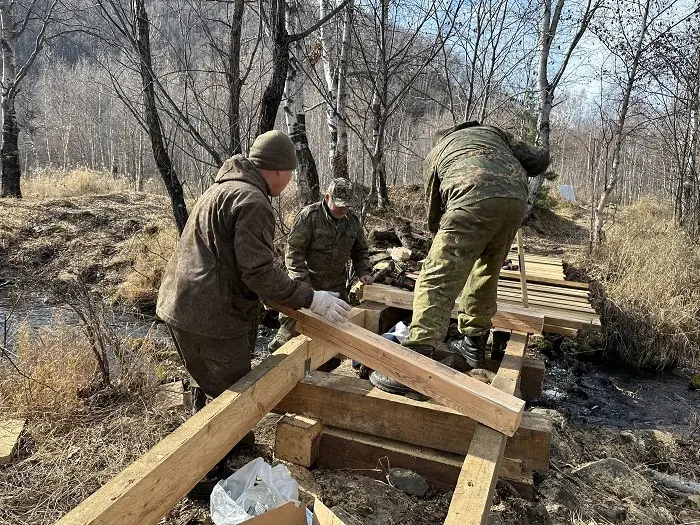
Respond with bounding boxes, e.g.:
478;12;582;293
209;458;299;525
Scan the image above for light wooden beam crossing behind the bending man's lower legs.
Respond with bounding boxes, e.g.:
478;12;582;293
362;284;544;334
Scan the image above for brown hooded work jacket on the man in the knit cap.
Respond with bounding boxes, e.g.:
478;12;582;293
156;155;313;339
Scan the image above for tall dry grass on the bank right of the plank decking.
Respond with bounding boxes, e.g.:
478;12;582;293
579;200;700;368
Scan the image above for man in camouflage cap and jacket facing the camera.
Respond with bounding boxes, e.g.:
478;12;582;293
269;178;372;354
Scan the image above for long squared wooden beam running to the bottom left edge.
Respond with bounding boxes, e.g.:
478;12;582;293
58;336;337;525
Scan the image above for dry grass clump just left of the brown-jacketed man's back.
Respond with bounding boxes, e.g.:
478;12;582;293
117;221;178;304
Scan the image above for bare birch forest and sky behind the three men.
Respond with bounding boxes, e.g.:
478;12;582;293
0;0;700;244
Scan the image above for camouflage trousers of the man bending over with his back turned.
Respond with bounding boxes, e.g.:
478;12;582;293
403;198;525;350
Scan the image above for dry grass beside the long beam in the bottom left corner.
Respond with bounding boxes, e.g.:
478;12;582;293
0;322;186;524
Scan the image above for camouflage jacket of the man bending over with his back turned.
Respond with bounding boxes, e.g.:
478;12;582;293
423;123;549;233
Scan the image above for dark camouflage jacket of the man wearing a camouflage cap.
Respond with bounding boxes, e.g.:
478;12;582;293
285;201;372;290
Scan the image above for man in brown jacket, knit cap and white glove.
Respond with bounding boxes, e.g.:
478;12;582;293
156;131;350;410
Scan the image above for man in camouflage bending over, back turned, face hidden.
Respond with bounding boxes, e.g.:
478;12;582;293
370;122;549;393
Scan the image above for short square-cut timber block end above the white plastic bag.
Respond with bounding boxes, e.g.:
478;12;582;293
275;414;323;468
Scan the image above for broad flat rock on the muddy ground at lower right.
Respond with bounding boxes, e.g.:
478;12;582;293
571;458;654;503
